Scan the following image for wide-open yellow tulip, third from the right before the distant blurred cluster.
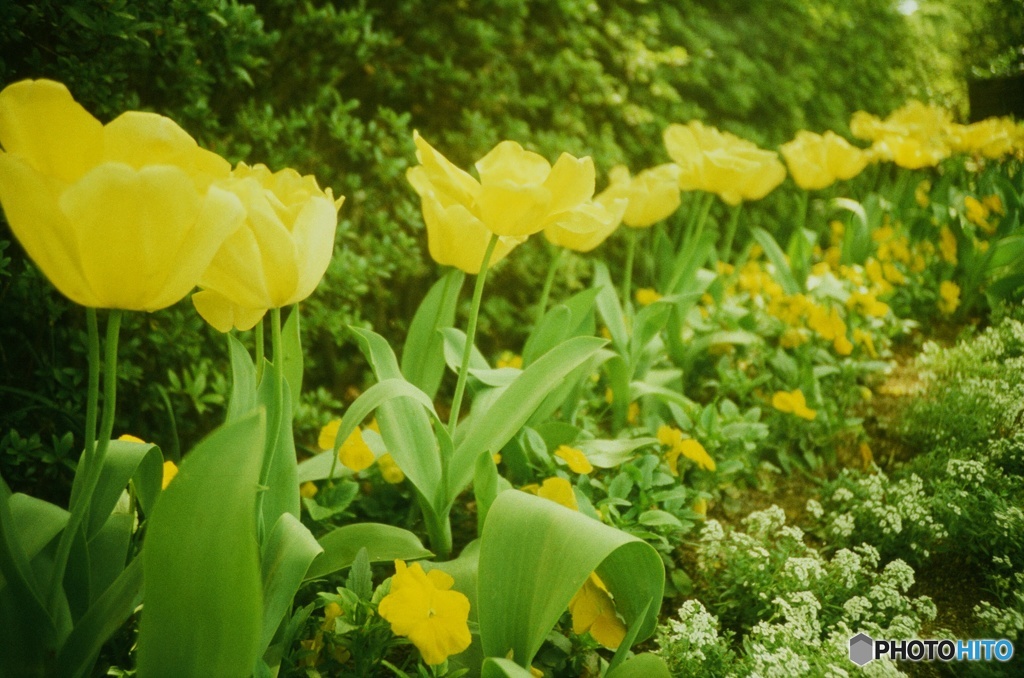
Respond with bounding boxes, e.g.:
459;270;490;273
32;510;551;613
664;120;785;205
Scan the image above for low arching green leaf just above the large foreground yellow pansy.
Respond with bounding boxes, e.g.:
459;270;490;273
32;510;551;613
305;522;433;581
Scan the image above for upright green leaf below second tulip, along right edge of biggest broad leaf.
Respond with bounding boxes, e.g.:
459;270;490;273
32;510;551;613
257;363;301;534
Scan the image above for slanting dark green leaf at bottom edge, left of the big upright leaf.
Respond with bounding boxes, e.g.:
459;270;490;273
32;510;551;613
56;558;142;676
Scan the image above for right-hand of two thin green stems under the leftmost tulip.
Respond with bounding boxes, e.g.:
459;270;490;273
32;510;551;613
47;308;121;619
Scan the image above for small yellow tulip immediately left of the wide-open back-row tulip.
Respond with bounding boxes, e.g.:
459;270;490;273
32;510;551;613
601;163;680;228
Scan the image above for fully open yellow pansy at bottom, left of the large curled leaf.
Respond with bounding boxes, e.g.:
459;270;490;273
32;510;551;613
377;560;472;666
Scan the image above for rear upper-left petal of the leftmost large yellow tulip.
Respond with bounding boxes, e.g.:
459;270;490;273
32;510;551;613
0;80;102;182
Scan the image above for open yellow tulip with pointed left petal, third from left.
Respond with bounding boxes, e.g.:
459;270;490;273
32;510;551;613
406;133;600;274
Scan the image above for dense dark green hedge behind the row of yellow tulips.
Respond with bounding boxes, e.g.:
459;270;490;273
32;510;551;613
0;0;925;499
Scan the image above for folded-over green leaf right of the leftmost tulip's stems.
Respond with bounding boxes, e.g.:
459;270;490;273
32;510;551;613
88;440;164;539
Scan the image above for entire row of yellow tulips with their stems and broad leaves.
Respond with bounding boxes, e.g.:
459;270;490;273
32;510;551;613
0;75;1021;676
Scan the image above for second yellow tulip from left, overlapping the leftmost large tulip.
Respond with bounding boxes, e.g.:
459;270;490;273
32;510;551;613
193;163;345;332
